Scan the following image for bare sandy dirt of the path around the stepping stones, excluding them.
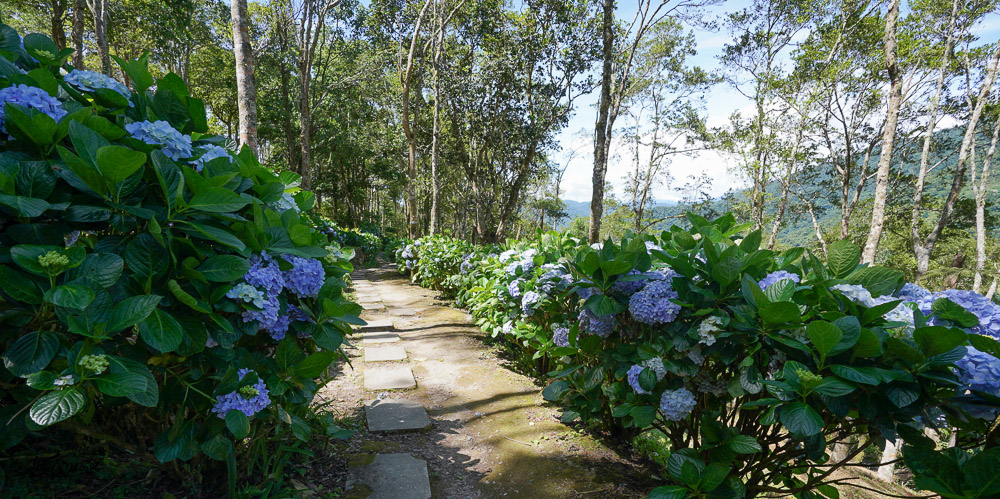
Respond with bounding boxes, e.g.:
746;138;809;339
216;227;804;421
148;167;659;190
319;267;654;498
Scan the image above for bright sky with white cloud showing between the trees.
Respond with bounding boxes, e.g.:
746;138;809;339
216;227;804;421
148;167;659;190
554;0;1000;204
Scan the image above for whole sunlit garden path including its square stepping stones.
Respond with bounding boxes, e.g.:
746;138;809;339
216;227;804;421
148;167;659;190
319;267;657;499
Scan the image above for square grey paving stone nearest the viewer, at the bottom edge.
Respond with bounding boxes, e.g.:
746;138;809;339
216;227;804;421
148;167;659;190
347;454;431;499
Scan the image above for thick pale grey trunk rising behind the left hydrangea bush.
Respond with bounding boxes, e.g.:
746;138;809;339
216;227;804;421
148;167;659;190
230;0;257;155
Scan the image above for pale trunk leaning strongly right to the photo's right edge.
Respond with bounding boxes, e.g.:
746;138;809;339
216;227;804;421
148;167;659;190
914;44;1000;277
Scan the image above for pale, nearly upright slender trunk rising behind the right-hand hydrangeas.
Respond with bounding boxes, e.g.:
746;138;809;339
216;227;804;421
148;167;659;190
861;0;903;263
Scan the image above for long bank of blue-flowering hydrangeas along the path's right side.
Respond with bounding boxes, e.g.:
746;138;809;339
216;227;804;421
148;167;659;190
400;215;1000;497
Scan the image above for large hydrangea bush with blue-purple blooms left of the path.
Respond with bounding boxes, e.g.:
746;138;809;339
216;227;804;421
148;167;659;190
0;25;360;488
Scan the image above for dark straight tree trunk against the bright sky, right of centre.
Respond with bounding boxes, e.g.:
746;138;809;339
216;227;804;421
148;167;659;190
589;0;615;243
